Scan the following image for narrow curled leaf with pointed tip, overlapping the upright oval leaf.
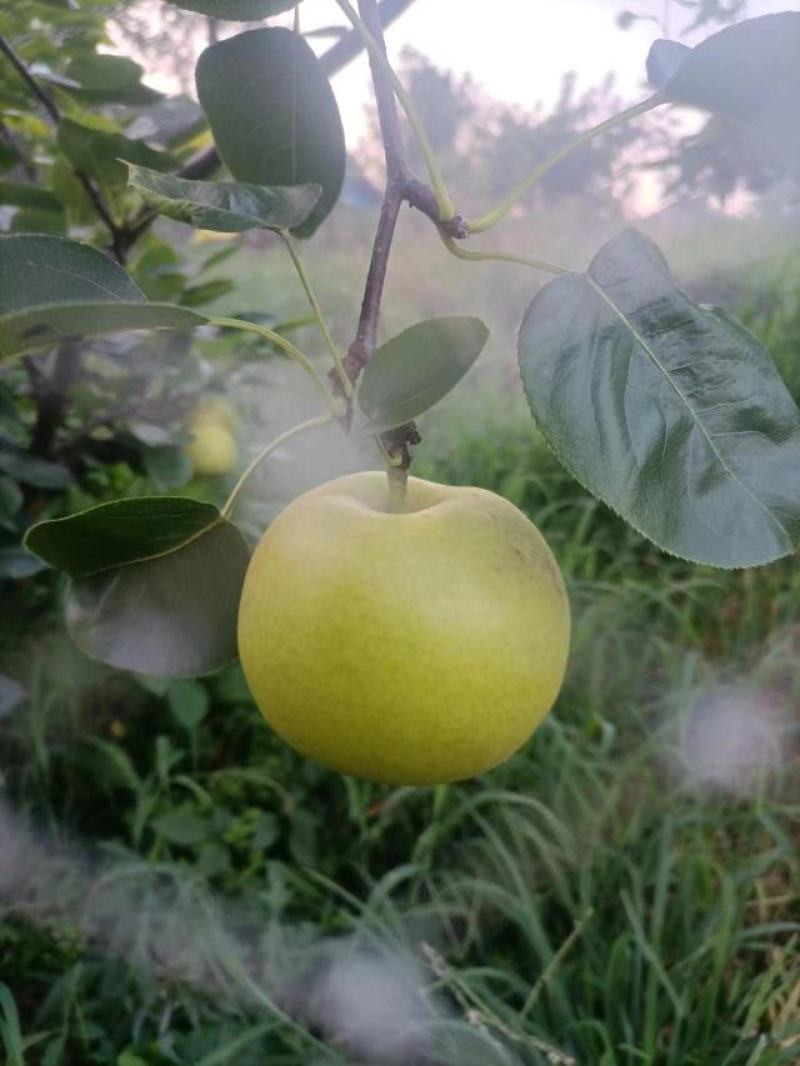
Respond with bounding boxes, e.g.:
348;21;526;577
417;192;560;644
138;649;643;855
128;165;322;233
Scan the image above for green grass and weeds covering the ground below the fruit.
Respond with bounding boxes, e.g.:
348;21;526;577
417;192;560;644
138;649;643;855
0;262;800;1066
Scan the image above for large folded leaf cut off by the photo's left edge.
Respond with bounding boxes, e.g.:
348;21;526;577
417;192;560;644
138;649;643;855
0;235;206;360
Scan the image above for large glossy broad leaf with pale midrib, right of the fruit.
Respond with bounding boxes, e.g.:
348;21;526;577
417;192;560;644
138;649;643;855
518;230;800;567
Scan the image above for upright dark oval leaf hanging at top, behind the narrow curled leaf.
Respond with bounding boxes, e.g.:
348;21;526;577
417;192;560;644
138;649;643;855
196;27;346;237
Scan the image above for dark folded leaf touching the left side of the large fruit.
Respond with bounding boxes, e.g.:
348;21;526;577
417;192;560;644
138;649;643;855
25;497;250;677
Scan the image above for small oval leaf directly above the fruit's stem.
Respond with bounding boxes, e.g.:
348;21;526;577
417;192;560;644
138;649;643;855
358;316;489;433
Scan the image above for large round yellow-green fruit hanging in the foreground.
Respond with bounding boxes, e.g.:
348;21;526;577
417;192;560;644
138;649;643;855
239;472;570;785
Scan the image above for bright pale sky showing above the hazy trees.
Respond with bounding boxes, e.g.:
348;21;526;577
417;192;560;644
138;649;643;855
279;0;800;147
